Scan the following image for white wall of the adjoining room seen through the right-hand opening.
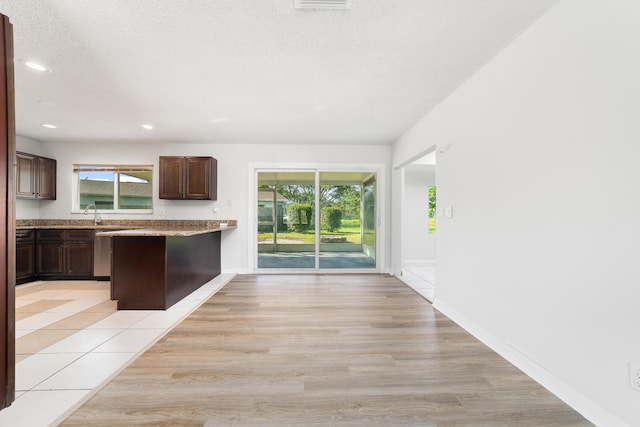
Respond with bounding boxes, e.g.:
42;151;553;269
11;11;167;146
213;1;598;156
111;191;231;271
402;165;436;261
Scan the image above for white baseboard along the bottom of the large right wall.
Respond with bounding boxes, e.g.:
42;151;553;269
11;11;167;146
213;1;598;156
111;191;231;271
433;299;630;427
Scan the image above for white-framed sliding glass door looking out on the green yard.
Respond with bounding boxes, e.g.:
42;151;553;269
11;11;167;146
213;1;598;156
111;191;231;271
254;169;378;272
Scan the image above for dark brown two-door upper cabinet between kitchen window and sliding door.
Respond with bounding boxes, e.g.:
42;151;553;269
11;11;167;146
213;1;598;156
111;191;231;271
160;156;218;200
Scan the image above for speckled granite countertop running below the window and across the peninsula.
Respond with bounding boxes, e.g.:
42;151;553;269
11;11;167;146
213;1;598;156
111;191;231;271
16;219;237;236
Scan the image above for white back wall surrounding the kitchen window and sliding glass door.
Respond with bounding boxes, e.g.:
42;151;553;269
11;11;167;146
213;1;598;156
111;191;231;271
18;142;391;272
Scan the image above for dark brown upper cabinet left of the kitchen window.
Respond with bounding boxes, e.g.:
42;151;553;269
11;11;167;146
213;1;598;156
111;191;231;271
16;152;57;200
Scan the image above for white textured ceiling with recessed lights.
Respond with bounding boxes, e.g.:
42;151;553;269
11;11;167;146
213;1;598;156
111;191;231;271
0;0;558;144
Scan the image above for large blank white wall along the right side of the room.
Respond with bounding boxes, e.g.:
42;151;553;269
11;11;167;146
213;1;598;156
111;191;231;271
393;0;640;426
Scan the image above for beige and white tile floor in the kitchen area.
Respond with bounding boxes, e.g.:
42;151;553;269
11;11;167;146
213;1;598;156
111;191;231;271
0;274;233;427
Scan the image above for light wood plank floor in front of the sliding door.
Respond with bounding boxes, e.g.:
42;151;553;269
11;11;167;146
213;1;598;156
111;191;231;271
62;275;591;427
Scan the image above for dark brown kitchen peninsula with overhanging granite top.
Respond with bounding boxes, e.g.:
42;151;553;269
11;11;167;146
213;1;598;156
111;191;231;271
96;220;236;310
